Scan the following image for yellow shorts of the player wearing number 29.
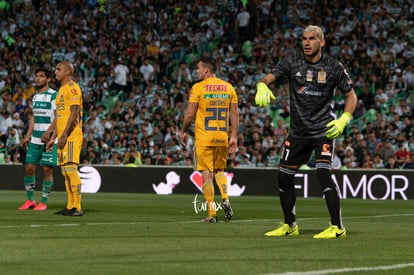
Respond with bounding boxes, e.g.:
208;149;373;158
194;146;229;172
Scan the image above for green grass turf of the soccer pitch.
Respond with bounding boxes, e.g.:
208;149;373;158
0;191;414;274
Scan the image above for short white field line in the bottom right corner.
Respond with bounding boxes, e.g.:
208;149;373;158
263;263;414;275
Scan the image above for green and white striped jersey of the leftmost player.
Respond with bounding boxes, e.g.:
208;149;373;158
31;88;57;145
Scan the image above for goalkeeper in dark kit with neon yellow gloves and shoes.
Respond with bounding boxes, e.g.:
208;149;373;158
256;26;357;239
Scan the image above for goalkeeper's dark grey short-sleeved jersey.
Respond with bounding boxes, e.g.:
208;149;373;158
272;52;353;138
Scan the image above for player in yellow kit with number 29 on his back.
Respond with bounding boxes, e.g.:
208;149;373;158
179;56;239;222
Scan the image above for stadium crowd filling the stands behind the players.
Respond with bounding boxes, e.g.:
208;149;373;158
0;0;414;169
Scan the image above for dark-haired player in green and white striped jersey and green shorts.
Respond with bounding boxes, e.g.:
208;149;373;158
19;67;57;210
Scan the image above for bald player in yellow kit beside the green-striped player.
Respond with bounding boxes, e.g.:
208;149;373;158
48;61;83;216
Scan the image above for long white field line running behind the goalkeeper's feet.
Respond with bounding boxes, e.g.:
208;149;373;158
0;213;414;229
